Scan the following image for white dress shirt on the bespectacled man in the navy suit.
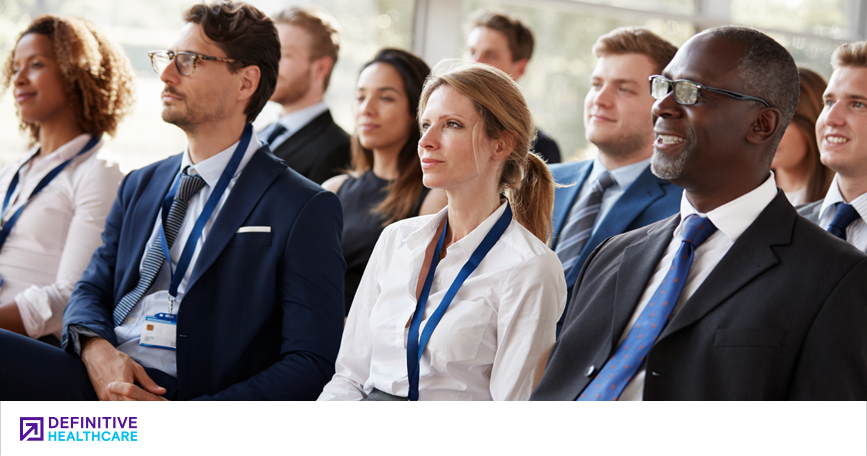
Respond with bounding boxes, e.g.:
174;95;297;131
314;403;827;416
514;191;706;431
114;132;260;377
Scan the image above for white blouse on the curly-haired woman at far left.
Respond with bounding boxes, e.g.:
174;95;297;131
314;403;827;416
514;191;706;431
0;134;123;338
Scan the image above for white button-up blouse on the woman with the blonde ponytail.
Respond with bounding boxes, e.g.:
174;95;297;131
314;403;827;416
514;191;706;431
319;204;566;400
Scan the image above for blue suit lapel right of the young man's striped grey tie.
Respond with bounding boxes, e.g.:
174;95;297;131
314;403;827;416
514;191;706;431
566;166;665;283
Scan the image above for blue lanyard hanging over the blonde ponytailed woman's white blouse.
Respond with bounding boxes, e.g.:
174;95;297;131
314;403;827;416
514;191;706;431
406;203;512;401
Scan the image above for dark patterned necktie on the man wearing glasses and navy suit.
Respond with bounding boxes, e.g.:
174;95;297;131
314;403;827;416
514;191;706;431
112;169;205;326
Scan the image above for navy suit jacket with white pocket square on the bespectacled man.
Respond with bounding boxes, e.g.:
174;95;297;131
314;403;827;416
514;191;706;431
63;146;346;400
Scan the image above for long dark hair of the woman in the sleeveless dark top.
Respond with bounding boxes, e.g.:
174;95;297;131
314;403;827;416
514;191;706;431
350;48;430;226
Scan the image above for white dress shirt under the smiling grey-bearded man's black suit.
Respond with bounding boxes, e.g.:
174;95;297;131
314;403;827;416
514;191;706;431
617;173;777;401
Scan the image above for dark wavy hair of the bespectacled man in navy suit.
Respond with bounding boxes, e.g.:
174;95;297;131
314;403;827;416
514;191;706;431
184;1;280;122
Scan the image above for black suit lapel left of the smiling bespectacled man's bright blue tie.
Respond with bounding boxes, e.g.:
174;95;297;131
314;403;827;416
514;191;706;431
611;214;680;350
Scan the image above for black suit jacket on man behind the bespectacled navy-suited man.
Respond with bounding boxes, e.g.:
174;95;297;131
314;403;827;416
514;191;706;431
274;110;349;184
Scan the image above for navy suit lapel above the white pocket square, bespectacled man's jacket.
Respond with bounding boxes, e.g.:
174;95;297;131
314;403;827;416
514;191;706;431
186;146;286;292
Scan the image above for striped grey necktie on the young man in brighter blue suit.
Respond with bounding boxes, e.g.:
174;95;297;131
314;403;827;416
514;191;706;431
554;171;617;276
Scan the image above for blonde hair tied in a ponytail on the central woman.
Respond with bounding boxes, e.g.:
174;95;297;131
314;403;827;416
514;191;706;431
419;61;555;243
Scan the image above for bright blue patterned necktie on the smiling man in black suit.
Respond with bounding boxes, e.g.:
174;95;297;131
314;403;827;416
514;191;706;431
578;214;716;401
